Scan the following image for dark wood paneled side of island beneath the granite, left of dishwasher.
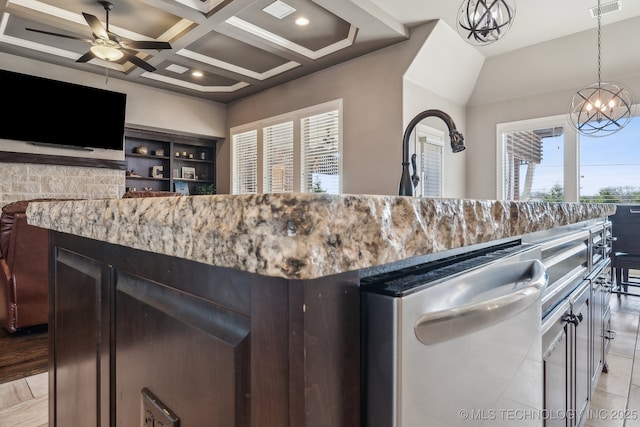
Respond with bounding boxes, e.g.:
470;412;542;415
49;232;360;427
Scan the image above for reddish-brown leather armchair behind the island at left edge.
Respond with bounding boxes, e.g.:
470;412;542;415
0;199;49;332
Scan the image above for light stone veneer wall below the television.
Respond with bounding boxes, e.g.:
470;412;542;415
0;163;125;206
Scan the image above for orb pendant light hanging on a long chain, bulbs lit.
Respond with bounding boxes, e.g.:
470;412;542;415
569;0;633;137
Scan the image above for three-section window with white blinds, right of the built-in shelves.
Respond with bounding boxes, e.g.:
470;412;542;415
231;100;342;194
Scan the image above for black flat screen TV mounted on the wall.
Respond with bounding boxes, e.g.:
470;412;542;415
0;70;127;150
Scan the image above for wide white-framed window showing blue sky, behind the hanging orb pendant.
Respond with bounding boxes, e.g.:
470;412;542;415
497;116;640;203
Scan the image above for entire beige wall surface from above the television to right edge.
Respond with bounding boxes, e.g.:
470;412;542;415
5;18;640;199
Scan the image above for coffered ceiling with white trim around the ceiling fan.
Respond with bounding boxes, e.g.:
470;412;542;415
0;0;407;102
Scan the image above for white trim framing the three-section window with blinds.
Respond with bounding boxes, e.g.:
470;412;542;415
229;99;344;194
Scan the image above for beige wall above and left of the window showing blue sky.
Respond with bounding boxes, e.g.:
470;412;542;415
465;18;640;199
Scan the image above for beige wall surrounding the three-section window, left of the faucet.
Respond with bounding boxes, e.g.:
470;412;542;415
224;23;435;194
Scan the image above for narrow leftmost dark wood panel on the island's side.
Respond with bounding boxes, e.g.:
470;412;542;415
51;249;109;426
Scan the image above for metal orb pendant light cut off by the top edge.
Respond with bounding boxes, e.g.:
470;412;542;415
457;0;516;46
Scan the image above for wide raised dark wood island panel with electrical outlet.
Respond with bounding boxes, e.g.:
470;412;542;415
115;271;250;427
